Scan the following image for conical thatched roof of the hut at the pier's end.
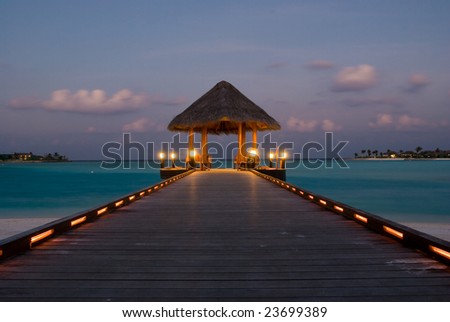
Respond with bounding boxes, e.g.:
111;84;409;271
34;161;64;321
168;81;281;134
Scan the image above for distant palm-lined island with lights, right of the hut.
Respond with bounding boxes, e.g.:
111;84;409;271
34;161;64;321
354;146;450;159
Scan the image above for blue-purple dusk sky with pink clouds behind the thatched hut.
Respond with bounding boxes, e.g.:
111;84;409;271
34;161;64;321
0;0;450;160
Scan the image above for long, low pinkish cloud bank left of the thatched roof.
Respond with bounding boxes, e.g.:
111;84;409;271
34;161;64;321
9;89;186;114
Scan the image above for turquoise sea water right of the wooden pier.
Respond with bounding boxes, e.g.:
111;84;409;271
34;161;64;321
287;160;450;224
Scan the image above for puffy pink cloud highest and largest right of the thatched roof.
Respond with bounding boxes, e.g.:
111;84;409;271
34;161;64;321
333;65;377;92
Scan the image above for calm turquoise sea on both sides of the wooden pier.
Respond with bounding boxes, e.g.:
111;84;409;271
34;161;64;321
0;161;450;224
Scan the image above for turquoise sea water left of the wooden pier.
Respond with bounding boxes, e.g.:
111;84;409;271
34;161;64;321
0;161;160;218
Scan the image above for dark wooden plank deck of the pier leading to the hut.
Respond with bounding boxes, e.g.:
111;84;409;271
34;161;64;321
0;170;450;301
